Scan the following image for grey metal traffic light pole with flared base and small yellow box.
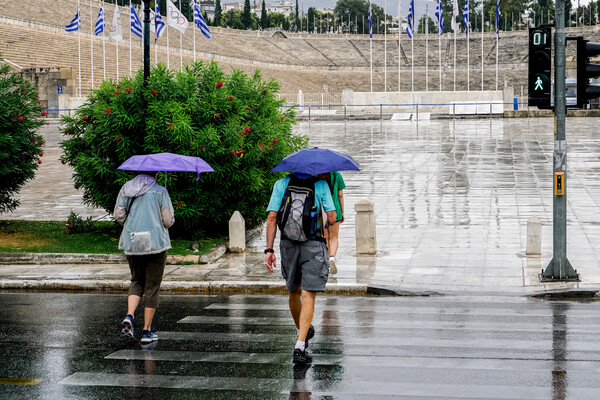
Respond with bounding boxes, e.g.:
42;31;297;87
540;0;579;282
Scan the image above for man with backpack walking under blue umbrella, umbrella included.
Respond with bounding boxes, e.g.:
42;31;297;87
265;148;358;364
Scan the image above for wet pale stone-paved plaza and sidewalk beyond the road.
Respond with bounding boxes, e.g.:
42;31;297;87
0;118;600;295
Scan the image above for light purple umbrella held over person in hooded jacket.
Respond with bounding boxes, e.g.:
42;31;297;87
117;153;215;180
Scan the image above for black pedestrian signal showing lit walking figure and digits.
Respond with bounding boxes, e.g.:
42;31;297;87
528;26;552;109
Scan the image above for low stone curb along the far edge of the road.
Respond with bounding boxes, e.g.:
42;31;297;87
0;279;368;295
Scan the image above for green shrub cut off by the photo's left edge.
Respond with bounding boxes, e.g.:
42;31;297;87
0;59;45;213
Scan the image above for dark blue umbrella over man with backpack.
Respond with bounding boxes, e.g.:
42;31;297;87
271;147;360;175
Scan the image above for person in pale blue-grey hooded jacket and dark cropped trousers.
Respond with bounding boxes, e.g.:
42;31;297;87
114;172;175;343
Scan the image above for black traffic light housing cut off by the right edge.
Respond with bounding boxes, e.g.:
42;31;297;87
577;37;600;108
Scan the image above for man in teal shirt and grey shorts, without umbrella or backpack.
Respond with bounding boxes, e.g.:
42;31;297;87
265;173;335;364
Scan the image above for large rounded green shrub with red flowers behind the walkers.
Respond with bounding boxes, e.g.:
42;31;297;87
61;63;307;233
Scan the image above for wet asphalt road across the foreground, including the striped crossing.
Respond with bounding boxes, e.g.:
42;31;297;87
0;292;600;399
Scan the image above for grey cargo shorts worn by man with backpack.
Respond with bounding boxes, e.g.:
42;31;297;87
279;239;329;292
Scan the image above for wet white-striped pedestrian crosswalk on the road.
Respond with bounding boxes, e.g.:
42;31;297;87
60;295;600;400
